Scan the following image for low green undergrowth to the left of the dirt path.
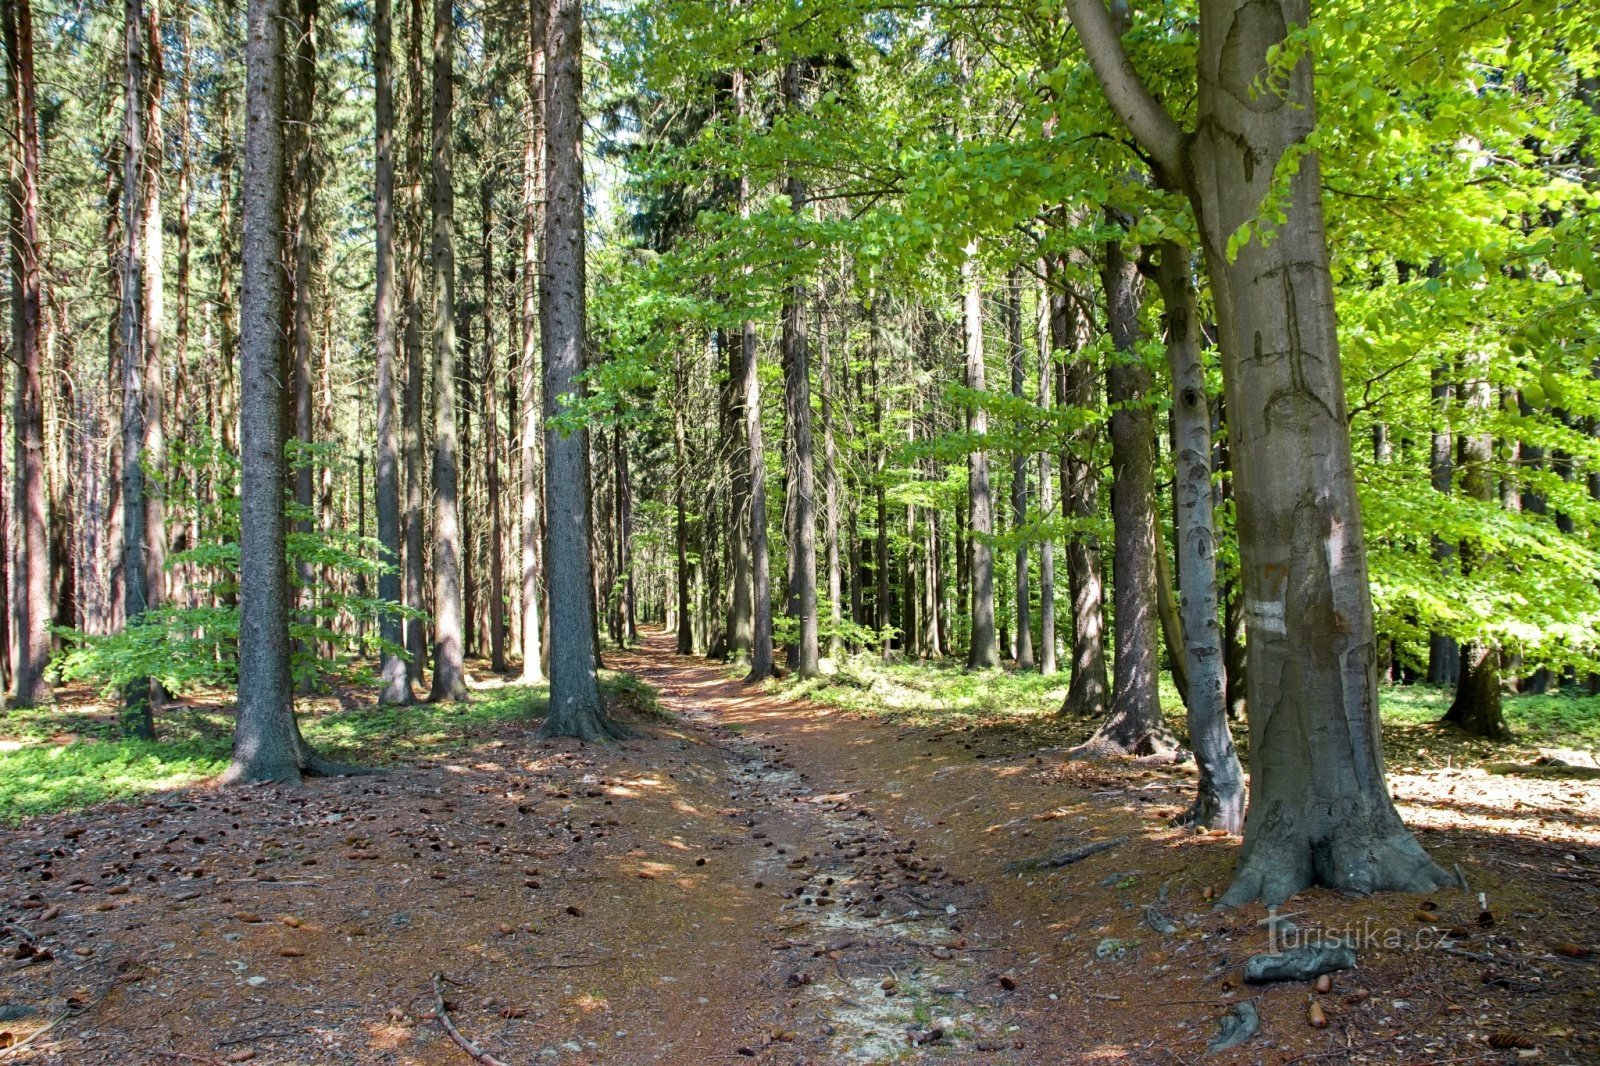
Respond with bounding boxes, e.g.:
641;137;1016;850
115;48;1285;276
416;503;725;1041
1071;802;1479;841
0;671;666;824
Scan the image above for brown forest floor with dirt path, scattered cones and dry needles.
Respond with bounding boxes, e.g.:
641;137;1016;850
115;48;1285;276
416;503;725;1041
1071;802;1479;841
0;634;1600;1066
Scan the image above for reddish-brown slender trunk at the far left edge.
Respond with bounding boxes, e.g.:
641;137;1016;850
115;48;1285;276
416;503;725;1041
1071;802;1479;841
0;0;51;707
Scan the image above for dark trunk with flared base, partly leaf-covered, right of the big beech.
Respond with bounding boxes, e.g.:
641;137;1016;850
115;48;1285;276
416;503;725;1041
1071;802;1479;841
1443;352;1510;741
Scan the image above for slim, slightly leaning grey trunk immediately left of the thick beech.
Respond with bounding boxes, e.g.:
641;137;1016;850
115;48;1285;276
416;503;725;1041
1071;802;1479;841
1155;240;1245;834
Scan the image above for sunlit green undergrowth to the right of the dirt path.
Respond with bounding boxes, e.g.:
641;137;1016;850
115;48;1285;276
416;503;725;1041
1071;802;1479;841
758;643;1600;758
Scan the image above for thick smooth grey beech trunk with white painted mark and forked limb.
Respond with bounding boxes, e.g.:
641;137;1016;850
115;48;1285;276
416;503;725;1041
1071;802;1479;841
1067;0;1454;904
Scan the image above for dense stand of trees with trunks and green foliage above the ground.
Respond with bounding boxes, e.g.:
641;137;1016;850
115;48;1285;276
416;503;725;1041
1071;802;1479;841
0;0;1600;900
